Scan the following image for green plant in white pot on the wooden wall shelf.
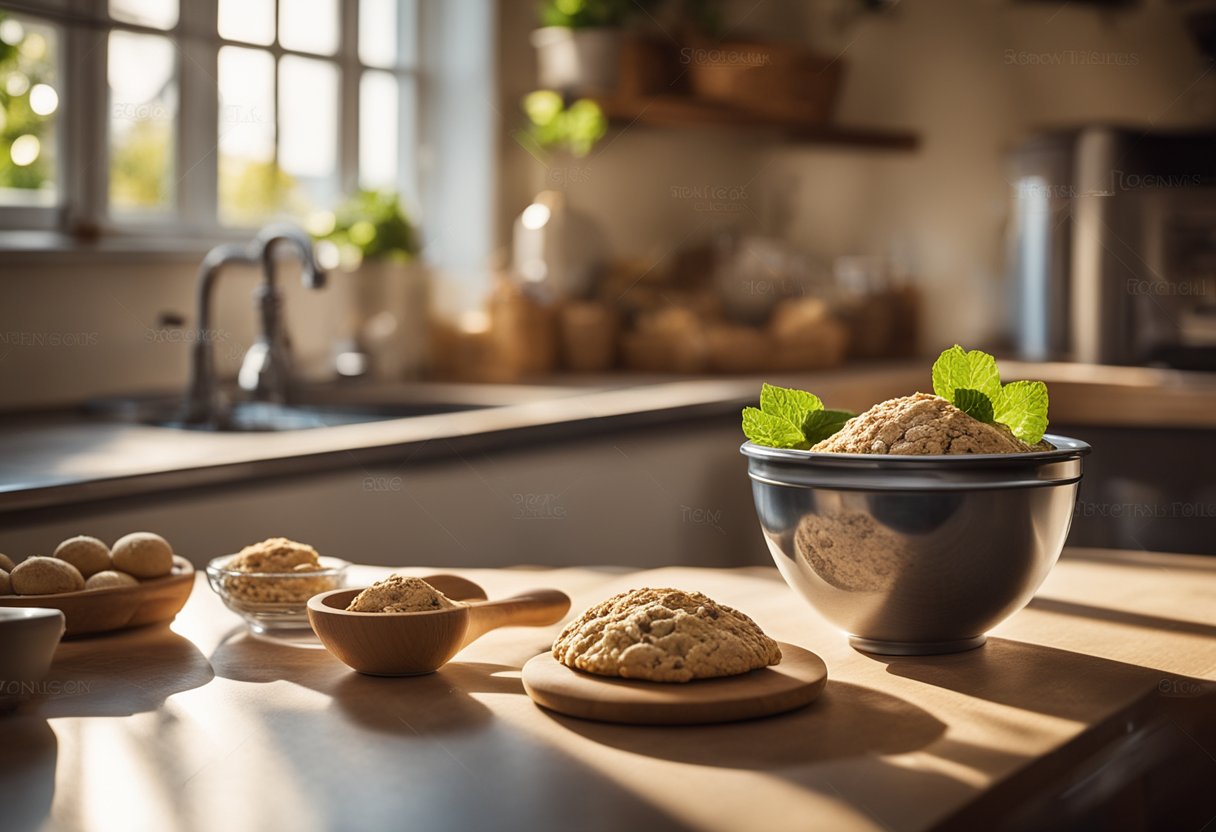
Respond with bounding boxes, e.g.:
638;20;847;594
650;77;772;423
531;0;655;94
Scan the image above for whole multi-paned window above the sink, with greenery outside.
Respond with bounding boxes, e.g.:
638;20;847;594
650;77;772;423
0;0;420;237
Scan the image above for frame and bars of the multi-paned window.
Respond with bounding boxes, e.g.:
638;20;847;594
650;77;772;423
0;0;427;248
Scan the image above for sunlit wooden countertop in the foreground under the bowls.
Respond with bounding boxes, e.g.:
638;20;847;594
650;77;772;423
0;550;1216;832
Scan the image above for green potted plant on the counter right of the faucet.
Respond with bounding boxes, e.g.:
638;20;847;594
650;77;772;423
309;191;430;381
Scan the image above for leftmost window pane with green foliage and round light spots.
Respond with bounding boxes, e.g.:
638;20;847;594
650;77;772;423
0;11;61;206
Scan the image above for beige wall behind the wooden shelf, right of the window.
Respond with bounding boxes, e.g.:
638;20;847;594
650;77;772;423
500;0;1216;349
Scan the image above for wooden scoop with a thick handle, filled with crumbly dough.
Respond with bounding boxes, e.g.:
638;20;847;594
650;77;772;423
308;575;570;676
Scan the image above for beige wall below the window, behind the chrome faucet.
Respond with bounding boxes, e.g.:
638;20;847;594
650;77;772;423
0;253;345;409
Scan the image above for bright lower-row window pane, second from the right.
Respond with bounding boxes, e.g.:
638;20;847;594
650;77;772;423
278;55;338;208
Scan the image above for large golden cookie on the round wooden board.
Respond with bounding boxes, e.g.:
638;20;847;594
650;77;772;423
553;589;781;682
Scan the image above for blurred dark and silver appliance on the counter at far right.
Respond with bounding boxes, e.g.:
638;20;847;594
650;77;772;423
1009;127;1216;370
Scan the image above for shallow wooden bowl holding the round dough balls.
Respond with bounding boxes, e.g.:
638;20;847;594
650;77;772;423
0;555;195;637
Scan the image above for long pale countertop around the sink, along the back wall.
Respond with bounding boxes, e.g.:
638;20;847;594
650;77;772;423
0;361;1216;513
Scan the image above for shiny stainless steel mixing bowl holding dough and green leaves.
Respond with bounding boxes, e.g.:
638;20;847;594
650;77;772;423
739;435;1090;656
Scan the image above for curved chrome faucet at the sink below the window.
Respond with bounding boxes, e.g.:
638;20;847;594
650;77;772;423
181;223;325;428
